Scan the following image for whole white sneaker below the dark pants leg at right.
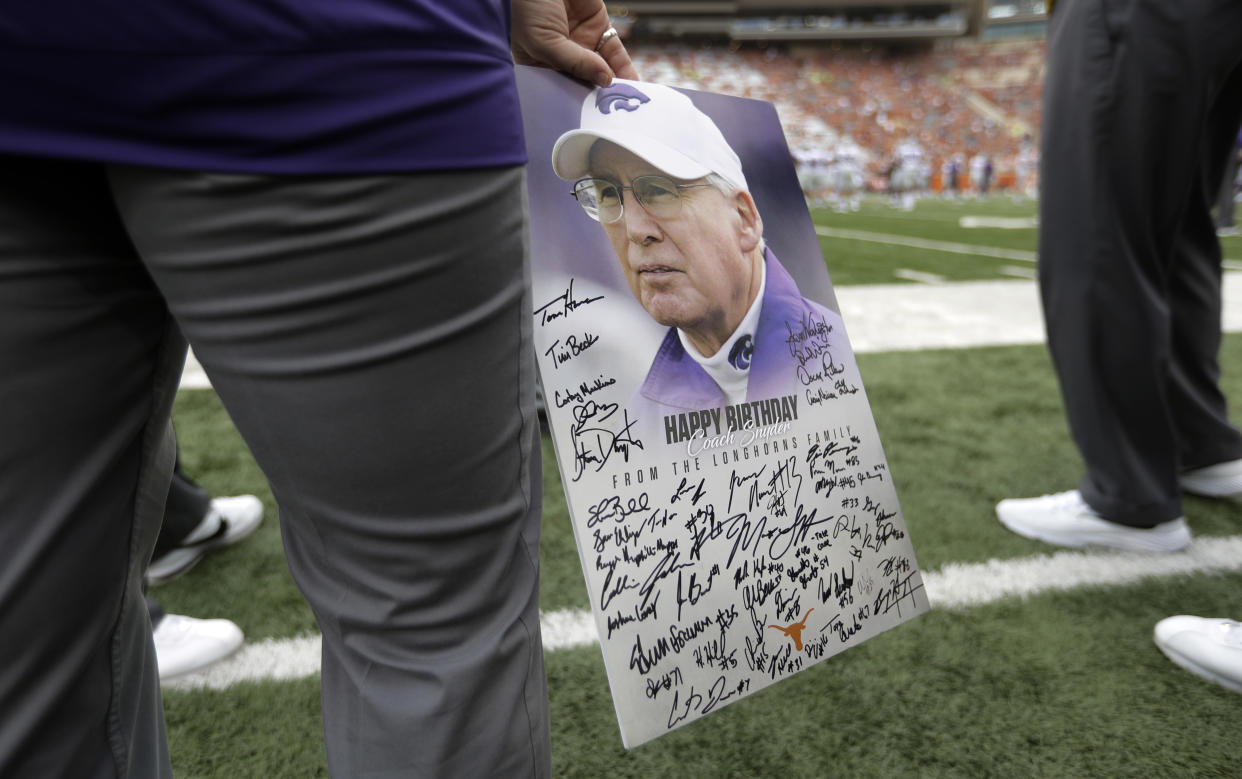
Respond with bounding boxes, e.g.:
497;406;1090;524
996;490;1190;552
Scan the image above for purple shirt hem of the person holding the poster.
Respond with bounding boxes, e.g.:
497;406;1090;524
0;0;525;174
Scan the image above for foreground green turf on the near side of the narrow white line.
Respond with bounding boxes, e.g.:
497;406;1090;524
165;574;1242;779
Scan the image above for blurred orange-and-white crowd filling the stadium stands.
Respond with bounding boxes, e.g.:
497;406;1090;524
632;39;1046;196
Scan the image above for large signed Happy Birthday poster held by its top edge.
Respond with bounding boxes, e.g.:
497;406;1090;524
519;68;928;747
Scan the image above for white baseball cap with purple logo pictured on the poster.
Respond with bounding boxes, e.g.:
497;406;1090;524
551;78;749;191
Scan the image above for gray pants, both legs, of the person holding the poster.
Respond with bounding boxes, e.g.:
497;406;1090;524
0;158;549;779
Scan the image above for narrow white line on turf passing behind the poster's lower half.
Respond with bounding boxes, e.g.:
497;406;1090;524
164;535;1242;690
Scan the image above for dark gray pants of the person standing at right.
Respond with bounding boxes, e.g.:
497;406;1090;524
1040;0;1242;527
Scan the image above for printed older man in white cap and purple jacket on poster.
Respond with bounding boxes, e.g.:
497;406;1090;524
551;80;857;427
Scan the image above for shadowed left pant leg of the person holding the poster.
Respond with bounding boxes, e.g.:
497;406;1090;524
0;158;178;778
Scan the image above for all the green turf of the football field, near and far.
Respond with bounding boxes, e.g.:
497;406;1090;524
153;198;1242;779
